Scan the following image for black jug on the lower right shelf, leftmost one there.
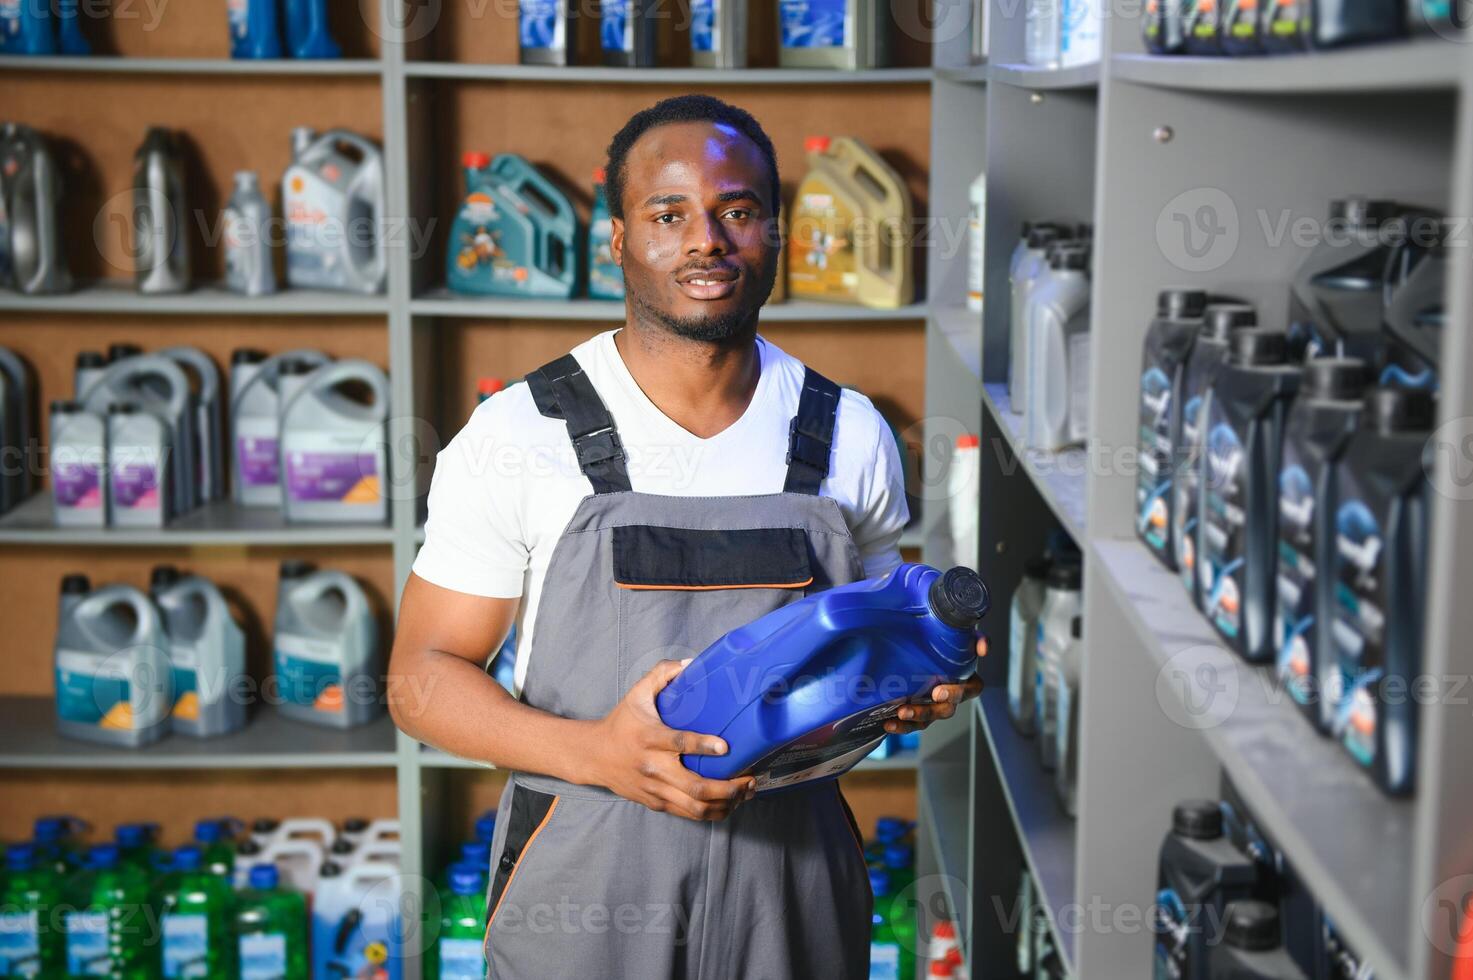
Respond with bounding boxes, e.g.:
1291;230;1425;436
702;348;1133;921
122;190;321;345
1152;800;1256;980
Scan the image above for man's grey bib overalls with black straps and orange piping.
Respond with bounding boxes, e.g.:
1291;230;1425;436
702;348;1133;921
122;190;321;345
486;355;873;980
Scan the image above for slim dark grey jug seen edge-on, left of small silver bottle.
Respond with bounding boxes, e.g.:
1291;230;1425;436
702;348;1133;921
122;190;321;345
133;127;190;293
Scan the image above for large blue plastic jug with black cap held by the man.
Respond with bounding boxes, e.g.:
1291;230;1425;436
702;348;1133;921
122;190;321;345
655;564;991;791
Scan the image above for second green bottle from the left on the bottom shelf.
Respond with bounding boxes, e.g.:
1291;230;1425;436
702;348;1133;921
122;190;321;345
66;844;159;980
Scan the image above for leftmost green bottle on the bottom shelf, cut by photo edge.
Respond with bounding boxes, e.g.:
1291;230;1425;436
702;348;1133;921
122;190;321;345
0;844;66;980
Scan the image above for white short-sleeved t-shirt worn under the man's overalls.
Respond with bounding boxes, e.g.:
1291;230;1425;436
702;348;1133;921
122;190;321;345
414;330;909;690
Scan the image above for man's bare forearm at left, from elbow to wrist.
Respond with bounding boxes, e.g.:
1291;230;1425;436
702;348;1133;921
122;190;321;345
389;650;598;785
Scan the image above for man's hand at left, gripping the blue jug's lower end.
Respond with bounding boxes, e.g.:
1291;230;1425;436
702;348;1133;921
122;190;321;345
589;660;757;821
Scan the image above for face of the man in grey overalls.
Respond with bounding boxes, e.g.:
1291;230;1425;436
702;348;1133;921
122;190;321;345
611;122;779;342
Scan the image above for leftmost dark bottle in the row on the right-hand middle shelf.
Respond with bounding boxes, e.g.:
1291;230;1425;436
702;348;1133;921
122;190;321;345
1136;289;1206;569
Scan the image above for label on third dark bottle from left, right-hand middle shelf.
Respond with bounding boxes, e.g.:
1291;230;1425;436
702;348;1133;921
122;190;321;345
1199;418;1246;640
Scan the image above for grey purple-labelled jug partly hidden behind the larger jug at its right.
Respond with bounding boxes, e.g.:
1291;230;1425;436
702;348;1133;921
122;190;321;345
230;349;328;507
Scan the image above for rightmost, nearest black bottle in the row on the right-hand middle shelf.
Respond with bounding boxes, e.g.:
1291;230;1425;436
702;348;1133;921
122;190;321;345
1330;388;1433;796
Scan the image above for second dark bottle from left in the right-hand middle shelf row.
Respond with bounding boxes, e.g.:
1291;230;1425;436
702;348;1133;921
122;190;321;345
1170;304;1258;609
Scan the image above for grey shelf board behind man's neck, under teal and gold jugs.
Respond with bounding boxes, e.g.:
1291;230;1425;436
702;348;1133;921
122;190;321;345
409;289;927;323
